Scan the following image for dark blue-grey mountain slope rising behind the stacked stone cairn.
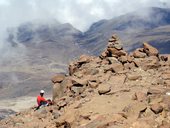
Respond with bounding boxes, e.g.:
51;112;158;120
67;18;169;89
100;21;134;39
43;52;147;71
79;7;170;55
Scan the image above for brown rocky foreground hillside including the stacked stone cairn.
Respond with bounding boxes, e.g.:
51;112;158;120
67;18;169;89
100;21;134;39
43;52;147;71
0;35;170;128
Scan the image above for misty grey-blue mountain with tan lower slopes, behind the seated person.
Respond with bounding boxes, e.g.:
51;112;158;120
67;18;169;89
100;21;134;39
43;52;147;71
0;22;86;98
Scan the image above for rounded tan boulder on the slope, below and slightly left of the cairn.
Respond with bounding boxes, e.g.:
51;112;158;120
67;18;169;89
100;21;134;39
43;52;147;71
98;84;111;95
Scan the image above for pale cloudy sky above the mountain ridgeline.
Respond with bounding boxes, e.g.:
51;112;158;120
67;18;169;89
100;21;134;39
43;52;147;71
0;0;170;31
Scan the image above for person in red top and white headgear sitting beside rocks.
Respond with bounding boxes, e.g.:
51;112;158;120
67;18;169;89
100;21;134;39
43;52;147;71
37;90;52;109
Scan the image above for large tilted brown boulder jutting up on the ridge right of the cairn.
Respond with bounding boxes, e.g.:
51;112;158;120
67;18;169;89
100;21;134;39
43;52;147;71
143;42;159;56
